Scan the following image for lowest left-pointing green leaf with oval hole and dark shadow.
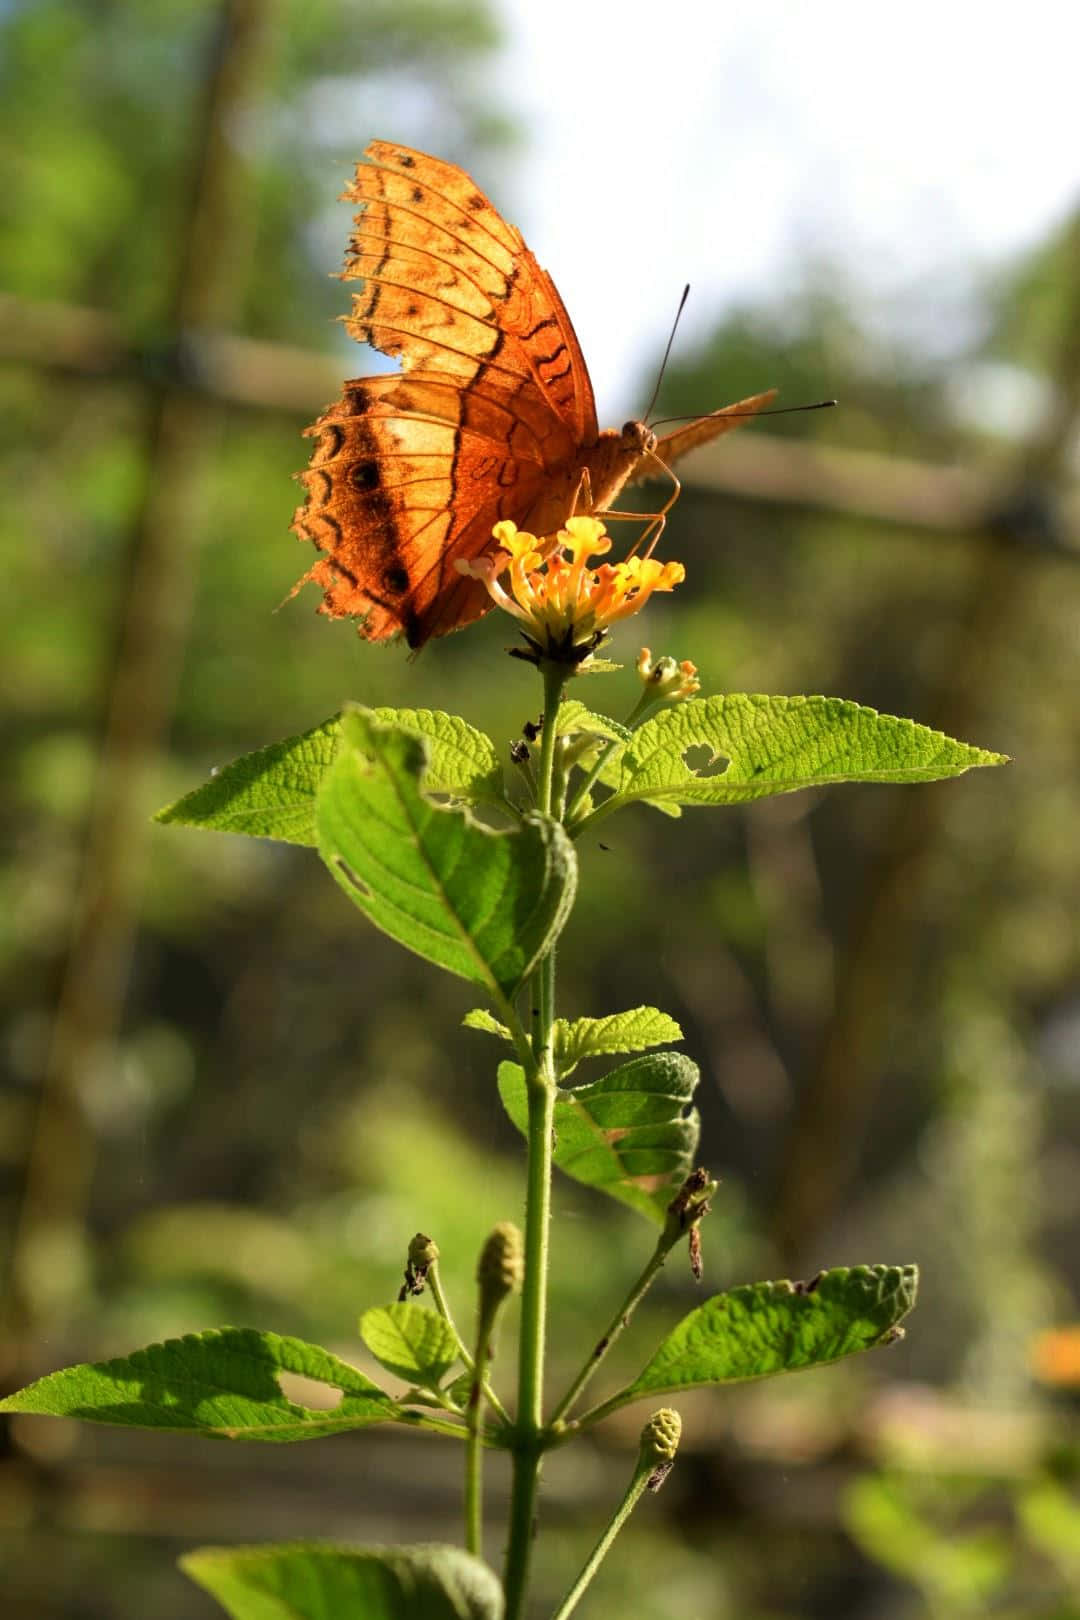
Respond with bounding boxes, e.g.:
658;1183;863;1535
0;1327;402;1440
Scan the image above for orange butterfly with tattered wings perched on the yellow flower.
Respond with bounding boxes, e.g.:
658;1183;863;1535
291;141;774;646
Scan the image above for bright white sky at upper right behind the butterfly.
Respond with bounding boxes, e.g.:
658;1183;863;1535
495;0;1080;424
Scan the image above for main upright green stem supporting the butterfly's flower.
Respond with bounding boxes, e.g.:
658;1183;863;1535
504;664;567;1620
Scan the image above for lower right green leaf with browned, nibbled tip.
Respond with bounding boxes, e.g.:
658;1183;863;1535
619;1265;918;1405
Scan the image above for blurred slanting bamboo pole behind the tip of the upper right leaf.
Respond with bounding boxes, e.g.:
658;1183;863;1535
772;215;1080;1268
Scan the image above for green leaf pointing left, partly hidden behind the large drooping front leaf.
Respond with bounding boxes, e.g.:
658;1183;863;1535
154;708;504;846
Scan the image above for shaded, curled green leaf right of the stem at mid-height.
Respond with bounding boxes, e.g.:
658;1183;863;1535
499;1051;699;1226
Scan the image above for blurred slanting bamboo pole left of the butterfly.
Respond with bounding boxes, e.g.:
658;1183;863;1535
5;0;281;1354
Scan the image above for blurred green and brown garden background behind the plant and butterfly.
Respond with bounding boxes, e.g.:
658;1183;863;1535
0;0;1080;1620
